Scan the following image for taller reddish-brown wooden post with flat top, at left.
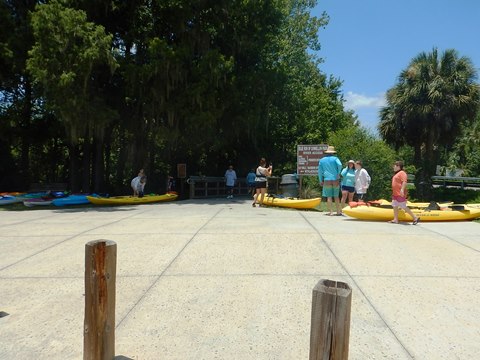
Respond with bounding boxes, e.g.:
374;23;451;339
83;240;117;360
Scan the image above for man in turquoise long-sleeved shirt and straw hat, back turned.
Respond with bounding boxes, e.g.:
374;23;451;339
318;146;342;216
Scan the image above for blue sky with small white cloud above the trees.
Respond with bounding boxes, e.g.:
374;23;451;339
312;0;480;131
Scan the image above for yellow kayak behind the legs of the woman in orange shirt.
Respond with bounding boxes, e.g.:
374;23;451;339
342;204;480;222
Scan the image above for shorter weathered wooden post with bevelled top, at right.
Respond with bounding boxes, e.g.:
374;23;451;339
310;279;352;360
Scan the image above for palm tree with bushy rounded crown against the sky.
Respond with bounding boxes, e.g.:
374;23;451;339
379;48;480;199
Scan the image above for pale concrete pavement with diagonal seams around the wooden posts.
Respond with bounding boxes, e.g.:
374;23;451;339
0;199;480;360
